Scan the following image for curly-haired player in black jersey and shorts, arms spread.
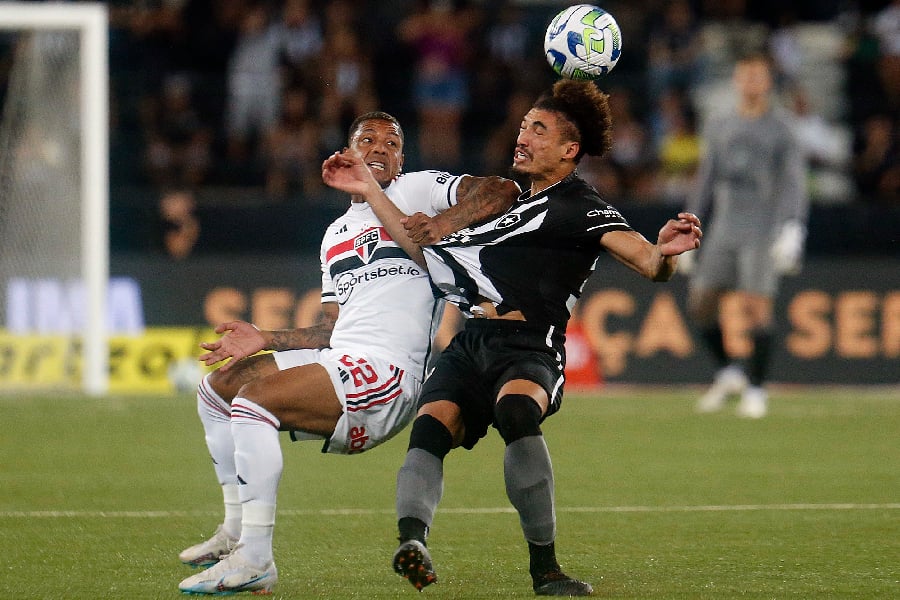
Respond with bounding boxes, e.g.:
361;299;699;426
323;80;702;596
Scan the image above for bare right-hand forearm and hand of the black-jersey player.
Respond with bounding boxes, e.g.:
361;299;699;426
601;213;703;281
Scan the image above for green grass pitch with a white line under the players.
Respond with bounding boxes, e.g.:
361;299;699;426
0;387;900;600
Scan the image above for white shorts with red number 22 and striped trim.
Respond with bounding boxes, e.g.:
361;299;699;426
273;348;422;454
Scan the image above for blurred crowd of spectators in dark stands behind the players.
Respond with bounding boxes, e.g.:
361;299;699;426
1;0;900;254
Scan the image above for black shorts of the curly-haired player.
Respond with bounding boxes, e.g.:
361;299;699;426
419;319;565;450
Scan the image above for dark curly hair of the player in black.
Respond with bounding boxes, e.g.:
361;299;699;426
534;79;612;163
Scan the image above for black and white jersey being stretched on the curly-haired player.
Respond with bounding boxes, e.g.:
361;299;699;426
424;172;631;331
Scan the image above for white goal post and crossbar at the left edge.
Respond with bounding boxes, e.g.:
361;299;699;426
0;2;109;395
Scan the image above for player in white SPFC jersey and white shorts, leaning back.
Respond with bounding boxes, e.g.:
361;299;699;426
179;112;519;594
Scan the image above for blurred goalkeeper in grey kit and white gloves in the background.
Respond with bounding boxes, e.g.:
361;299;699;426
682;54;808;418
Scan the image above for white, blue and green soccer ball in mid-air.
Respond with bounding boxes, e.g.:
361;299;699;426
544;4;622;79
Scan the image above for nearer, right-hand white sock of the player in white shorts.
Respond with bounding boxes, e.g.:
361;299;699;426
231;398;284;567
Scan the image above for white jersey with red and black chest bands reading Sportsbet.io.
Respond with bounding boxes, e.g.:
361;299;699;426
320;171;460;378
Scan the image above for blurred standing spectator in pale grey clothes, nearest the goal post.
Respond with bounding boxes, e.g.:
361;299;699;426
225;2;281;172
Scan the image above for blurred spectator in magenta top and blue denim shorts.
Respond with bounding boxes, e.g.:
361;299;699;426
398;0;482;171
